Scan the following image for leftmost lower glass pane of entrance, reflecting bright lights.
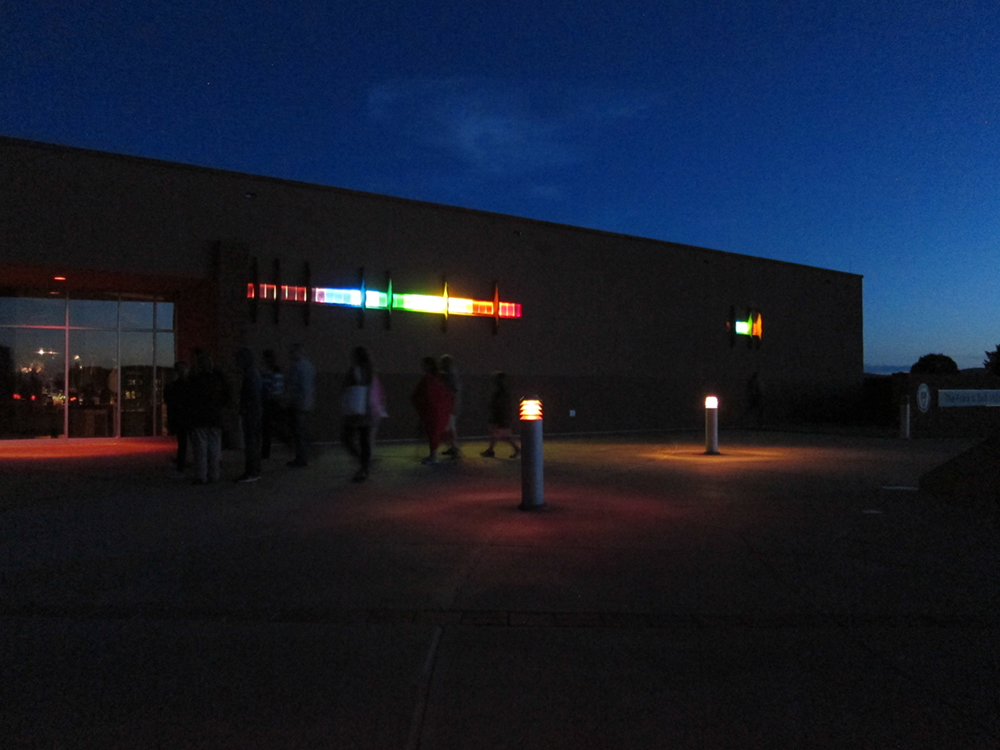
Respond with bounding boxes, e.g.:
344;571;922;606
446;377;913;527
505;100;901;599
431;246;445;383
0;328;66;438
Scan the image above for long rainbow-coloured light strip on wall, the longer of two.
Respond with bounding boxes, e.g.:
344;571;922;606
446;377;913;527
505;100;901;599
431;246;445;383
247;284;521;318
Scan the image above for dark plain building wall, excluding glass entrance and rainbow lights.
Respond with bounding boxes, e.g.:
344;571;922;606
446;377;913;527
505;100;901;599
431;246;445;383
0;139;863;437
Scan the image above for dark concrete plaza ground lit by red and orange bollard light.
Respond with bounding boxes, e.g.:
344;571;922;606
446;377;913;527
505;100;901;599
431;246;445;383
0;432;1000;750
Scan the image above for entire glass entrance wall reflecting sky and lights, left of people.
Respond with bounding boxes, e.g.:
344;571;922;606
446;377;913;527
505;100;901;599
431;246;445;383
0;295;175;438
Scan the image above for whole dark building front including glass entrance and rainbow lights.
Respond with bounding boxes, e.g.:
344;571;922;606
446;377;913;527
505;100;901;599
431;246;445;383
0;139;863;438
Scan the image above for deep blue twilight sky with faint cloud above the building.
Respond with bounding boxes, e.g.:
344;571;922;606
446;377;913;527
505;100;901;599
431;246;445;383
0;0;1000;371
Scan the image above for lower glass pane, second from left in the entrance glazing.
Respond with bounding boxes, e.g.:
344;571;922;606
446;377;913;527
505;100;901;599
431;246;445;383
69;330;118;437
